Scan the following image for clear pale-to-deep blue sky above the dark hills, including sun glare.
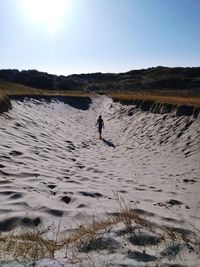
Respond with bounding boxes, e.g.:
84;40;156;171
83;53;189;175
0;0;200;75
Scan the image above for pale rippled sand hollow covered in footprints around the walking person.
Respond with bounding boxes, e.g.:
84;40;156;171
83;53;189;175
0;96;200;266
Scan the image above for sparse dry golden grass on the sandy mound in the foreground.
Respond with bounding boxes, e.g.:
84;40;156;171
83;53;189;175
0;205;200;266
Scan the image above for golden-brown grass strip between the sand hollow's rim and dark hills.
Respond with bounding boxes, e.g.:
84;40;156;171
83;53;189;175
0;80;200;106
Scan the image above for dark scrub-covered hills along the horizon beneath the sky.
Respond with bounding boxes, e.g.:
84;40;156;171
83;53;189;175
0;67;200;94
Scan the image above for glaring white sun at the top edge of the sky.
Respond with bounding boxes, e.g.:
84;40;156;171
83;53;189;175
21;0;68;32
